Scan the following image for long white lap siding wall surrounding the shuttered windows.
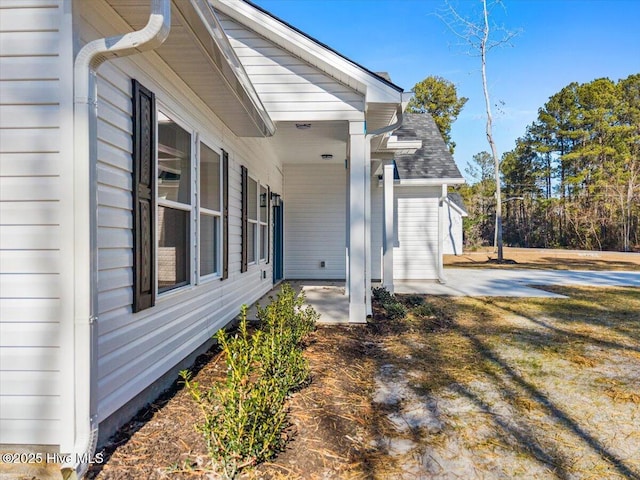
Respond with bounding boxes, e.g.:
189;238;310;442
81;3;282;421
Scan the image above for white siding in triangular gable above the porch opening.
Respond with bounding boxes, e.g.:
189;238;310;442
220;14;364;121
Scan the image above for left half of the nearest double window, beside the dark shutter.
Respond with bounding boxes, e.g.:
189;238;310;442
156;111;193;293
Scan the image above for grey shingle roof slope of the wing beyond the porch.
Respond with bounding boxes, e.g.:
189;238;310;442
393;113;464;184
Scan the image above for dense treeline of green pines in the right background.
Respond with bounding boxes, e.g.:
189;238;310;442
461;74;640;251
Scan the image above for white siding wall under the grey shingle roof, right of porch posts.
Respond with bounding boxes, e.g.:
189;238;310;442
393;186;440;280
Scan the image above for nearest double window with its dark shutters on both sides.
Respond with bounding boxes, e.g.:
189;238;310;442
132;80;229;312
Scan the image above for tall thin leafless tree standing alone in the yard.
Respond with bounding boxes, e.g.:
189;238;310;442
445;0;516;262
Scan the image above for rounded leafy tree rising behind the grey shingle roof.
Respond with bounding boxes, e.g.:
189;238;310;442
407;76;468;153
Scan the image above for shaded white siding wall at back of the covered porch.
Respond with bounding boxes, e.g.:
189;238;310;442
284;163;346;279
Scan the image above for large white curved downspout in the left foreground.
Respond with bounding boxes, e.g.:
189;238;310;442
62;0;171;479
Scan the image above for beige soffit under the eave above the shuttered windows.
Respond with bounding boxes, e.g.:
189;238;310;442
107;0;274;137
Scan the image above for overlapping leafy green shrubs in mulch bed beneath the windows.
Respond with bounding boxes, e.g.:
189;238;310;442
180;284;318;478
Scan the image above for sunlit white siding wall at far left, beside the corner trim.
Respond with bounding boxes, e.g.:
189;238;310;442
0;0;72;445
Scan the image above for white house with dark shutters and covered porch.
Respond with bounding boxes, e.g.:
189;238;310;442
0;0;460;473
